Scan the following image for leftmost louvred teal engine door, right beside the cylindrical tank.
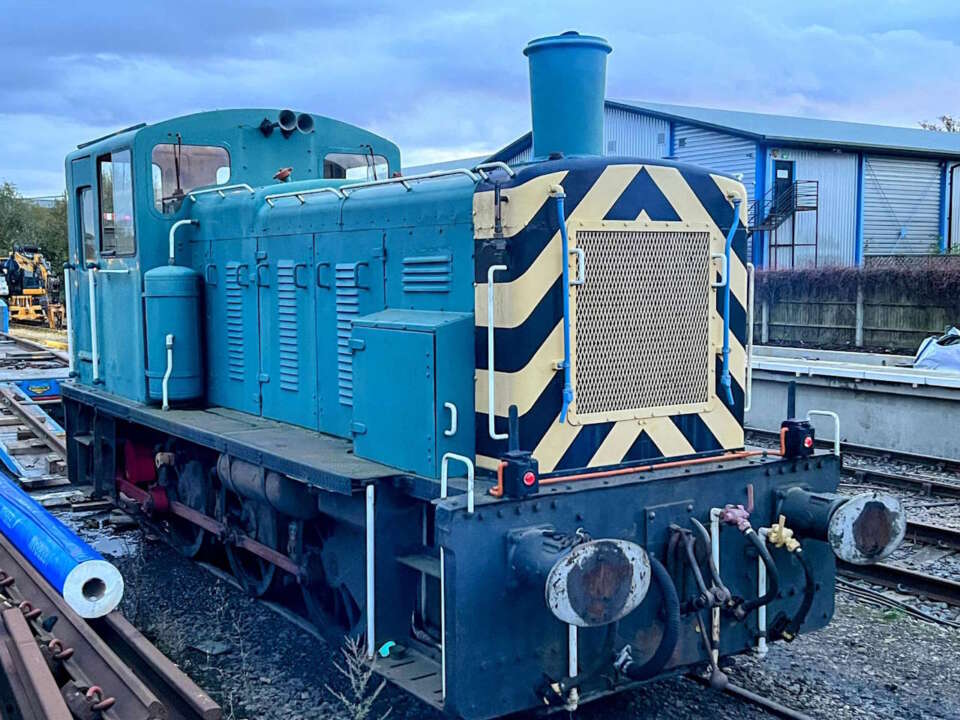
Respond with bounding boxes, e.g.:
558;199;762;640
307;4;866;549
204;238;260;415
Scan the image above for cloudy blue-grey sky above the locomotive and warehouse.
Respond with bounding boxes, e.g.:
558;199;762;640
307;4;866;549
0;0;960;195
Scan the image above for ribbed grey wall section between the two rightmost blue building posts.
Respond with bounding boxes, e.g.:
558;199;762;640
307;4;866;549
863;156;940;255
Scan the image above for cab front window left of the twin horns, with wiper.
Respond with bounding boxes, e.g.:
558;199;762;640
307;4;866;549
151;142;230;214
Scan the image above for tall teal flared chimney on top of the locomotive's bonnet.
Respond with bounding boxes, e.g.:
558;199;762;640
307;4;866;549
523;31;611;160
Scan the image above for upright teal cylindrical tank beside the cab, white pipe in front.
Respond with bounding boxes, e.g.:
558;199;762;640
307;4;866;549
143;265;203;402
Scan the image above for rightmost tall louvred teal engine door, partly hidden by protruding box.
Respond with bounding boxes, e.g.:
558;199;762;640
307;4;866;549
314;230;389;437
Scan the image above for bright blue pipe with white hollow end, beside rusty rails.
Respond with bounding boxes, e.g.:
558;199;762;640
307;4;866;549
0;478;123;618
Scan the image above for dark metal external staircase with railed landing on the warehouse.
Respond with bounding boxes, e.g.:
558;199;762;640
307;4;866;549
747;180;820;268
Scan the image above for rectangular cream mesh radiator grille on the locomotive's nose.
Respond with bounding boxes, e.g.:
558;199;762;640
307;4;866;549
574;230;711;415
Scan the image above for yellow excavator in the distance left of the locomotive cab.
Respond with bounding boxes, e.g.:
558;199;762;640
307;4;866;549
0;245;63;330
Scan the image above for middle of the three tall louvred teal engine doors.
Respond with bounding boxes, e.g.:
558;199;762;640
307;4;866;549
256;235;318;429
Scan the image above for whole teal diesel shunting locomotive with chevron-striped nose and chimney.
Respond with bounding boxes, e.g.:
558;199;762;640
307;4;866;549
63;33;904;718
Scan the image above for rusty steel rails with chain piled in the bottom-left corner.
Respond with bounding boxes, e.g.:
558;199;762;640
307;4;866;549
0;524;221;720
